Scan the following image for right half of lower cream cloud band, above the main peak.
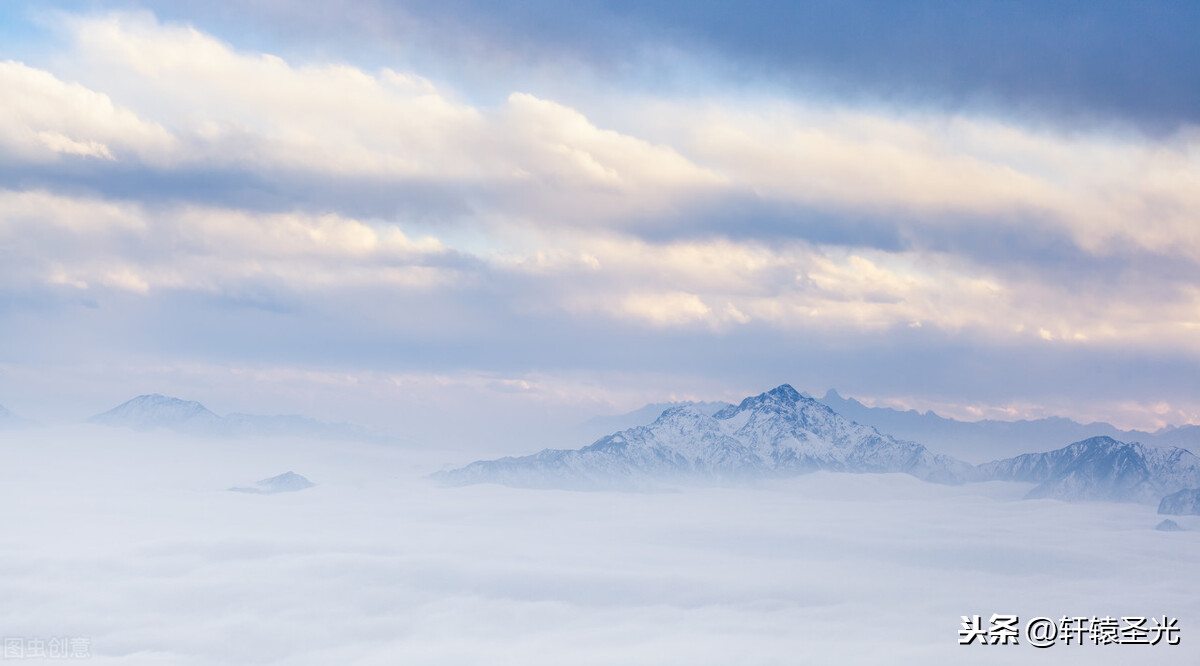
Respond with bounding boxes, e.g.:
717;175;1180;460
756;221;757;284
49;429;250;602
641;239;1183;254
490;225;1200;354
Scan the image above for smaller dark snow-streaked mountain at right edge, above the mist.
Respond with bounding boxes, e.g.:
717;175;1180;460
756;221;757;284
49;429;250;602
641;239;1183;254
978;437;1200;503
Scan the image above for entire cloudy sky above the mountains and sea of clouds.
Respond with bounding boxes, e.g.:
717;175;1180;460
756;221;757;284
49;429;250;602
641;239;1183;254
0;0;1200;439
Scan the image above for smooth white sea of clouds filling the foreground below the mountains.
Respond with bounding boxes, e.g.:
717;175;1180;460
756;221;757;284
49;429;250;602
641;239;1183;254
0;426;1200;666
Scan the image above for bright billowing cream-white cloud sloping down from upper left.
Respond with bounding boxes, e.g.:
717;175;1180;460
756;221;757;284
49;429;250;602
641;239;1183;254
46;14;720;212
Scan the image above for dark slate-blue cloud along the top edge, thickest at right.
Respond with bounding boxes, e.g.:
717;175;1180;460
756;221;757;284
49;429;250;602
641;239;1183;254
121;0;1200;131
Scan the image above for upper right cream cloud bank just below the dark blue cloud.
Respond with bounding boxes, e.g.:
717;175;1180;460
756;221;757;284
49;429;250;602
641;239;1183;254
643;102;1200;260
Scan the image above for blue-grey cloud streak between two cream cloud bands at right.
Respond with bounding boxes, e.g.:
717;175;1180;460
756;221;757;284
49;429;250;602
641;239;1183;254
600;191;1200;298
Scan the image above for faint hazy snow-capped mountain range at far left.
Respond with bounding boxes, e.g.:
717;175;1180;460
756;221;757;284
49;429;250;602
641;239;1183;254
88;394;388;440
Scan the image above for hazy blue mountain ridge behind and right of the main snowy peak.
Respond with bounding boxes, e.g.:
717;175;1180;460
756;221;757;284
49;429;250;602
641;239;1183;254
820;389;1200;462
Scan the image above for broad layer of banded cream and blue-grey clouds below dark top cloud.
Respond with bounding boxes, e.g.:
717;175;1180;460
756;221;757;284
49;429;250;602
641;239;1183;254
0;4;1200;425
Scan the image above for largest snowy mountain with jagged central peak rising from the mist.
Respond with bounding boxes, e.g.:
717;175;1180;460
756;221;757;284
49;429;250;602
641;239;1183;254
434;384;972;488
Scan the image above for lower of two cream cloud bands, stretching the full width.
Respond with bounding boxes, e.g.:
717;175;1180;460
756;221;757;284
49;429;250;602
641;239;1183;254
0;182;1200;360
